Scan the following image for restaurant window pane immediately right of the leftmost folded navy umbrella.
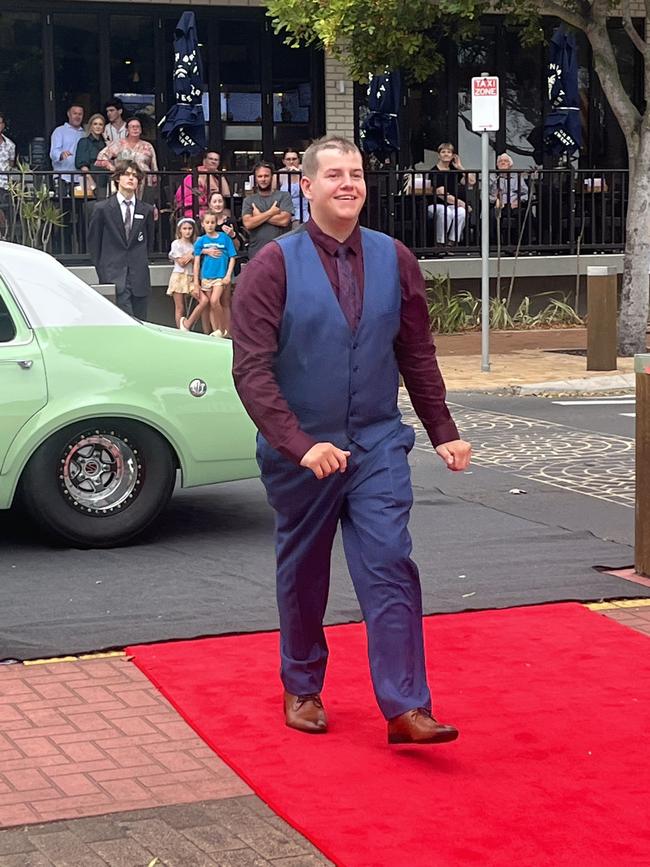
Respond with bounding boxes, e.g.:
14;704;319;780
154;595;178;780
219;20;263;171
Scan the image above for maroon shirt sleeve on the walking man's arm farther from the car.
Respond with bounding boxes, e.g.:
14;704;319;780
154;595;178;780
395;241;459;447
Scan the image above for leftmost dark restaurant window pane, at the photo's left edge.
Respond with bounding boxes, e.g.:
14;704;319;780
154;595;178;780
0;12;43;158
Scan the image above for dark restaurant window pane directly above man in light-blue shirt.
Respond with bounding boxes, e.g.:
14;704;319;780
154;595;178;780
52;13;100;125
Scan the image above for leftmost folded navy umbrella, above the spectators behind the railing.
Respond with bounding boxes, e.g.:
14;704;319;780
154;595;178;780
158;12;206;154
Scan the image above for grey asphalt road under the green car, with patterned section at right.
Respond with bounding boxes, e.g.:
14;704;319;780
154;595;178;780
0;394;650;659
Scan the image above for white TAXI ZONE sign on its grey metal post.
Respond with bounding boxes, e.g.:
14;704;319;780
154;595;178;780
472;72;499;373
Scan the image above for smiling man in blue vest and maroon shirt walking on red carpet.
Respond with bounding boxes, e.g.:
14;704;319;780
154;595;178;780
232;137;471;744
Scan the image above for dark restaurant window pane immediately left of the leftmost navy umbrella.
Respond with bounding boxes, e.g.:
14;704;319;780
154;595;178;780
110;15;157;141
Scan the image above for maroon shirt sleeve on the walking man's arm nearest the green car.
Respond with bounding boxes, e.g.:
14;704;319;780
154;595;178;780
231;241;316;464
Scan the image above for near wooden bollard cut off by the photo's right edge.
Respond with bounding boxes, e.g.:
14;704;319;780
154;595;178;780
634;355;650;576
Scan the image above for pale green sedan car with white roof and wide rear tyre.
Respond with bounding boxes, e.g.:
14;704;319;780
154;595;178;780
0;242;258;547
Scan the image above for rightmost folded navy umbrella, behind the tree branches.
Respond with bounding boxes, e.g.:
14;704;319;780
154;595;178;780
544;27;582;156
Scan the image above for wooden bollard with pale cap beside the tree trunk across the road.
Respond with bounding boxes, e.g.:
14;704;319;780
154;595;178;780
587;265;618;370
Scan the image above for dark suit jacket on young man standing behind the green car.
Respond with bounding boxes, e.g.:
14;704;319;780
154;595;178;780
87;195;154;297
